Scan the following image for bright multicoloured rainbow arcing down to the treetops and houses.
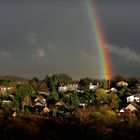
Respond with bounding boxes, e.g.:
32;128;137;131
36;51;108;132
82;0;112;80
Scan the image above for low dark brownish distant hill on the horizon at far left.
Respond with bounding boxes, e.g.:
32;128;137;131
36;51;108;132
0;75;29;82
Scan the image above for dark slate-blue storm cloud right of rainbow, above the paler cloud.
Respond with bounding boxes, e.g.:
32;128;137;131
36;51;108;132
98;0;140;49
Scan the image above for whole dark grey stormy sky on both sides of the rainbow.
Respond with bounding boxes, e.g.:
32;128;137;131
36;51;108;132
0;0;140;79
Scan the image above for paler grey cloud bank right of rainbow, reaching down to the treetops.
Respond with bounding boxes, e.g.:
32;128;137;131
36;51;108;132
108;45;140;77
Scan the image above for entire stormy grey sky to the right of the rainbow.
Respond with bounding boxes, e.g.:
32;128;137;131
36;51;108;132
94;0;140;76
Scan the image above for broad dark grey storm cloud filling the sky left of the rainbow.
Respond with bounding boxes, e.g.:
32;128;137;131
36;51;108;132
0;1;94;79
